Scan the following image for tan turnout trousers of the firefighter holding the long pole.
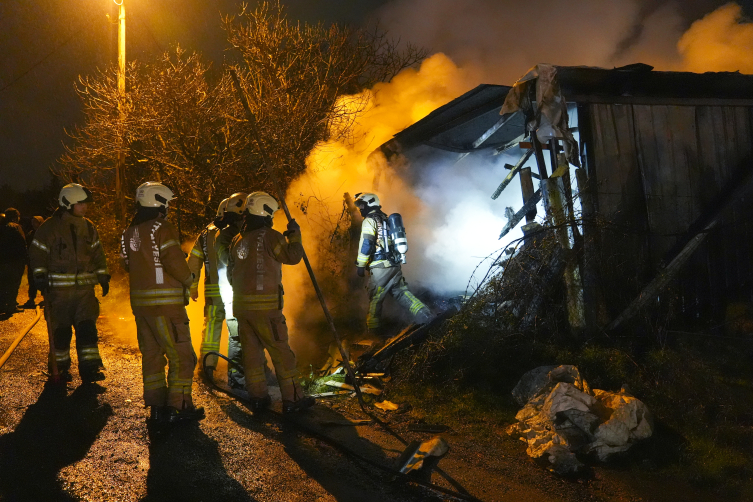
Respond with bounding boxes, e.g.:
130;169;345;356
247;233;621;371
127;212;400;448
236;310;303;401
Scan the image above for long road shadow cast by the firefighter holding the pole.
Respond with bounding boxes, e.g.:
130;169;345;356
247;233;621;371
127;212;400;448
223;403;428;502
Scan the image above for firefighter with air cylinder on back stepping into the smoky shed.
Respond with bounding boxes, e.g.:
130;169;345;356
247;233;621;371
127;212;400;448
355;193;432;336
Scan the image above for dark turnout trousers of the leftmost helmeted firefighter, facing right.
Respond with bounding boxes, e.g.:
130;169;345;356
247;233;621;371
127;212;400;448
44;287;104;374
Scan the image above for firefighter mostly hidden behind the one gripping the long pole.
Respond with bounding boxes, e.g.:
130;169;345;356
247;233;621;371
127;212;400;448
188;192;247;389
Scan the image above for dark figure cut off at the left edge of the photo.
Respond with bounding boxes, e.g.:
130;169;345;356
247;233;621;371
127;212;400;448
0;207;28;318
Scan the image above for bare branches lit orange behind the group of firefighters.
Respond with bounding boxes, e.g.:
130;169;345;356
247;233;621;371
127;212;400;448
54;2;425;270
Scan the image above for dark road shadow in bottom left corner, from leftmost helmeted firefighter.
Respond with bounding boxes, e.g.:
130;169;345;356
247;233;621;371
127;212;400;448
0;384;113;502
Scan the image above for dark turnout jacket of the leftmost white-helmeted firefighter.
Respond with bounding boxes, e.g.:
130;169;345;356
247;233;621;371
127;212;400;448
29;208;110;289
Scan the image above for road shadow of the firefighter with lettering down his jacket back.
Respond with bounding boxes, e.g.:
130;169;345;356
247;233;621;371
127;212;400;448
142;422;255;502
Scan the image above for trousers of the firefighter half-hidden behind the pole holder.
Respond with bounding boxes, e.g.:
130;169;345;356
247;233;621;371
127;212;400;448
201;302;245;388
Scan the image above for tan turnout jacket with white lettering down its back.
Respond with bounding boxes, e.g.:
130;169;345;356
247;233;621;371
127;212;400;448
120;217;193;316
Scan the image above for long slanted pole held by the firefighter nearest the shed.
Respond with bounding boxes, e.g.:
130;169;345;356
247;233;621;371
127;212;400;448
230;68;366;411
